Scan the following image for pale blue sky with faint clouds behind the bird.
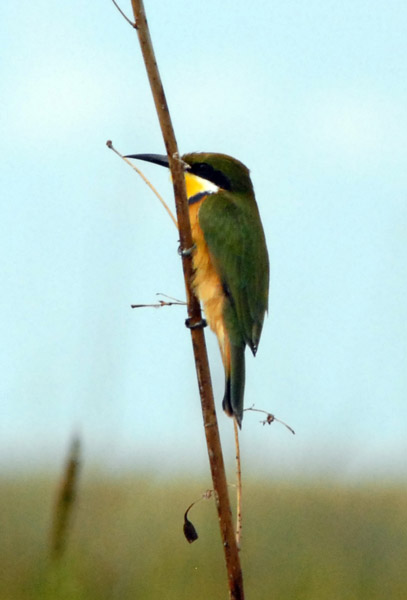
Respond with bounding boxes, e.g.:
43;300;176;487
0;0;407;480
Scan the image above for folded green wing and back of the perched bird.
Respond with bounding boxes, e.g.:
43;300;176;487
199;191;269;354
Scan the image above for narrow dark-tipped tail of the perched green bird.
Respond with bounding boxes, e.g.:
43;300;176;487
222;344;245;428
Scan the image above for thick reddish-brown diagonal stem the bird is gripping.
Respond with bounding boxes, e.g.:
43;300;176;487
131;0;244;600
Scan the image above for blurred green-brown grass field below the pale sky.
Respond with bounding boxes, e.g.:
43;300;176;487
0;477;407;600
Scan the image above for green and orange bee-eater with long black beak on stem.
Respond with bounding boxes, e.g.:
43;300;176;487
126;152;270;428
